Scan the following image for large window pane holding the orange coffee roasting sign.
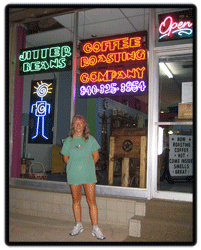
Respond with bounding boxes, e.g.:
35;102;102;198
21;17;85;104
77;8;149;188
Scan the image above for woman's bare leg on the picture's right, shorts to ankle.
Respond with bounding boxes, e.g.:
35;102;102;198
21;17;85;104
83;183;98;225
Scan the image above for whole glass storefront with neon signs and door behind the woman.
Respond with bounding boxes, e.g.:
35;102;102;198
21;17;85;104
9;5;196;202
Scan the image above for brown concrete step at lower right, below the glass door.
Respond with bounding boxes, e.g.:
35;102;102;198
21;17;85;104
129;200;193;242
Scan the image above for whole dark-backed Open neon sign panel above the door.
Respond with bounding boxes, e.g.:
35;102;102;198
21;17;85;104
158;9;193;41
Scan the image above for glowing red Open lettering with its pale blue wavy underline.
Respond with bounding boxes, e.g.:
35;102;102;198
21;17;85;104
159;16;193;39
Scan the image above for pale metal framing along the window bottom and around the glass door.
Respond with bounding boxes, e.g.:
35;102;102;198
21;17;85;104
9;9;193;201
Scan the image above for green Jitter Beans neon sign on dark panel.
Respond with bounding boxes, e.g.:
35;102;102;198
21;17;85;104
19;42;72;74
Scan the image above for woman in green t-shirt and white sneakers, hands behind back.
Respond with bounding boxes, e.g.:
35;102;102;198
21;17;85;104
61;115;105;240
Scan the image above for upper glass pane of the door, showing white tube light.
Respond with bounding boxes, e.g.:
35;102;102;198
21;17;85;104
159;54;193;118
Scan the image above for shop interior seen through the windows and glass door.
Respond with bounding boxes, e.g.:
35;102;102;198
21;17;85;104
16;8;193;193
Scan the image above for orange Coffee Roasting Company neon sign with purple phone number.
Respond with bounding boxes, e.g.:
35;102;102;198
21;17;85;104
80;31;147;97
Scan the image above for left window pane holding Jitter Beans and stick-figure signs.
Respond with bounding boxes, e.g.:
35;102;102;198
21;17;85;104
21;13;74;181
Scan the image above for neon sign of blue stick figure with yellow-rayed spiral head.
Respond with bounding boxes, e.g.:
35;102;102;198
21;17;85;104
29;80;55;144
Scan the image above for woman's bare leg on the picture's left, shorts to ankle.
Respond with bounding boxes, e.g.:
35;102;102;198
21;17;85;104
70;185;82;222
